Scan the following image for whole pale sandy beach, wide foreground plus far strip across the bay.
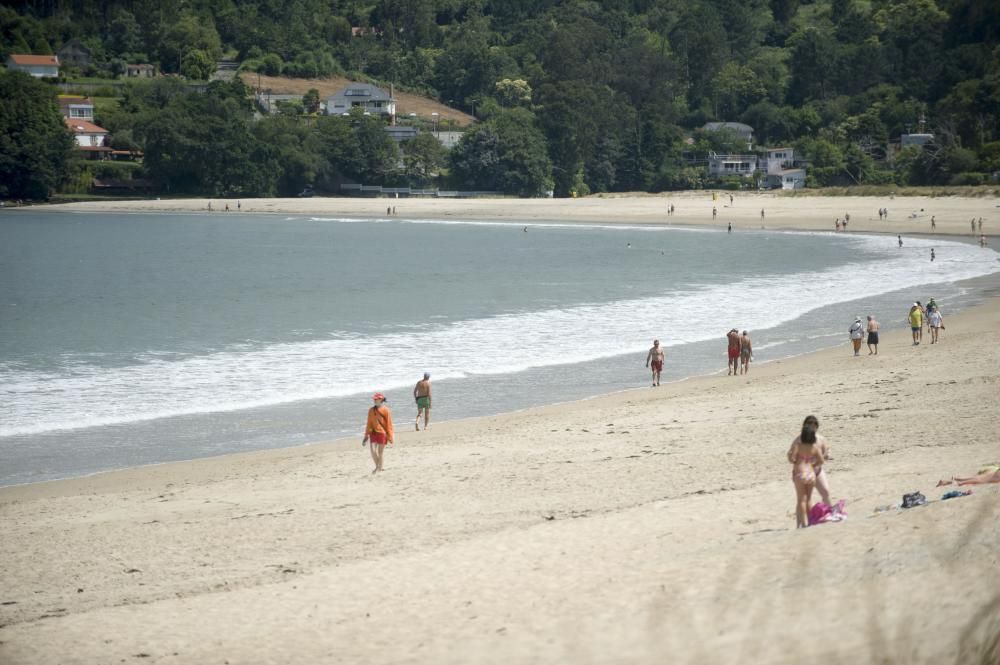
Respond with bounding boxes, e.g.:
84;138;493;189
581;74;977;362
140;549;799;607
0;194;1000;665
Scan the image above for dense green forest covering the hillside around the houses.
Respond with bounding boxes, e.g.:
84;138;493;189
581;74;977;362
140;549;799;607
0;0;1000;195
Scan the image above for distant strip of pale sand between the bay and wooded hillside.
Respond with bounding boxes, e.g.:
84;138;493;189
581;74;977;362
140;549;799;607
47;191;1000;238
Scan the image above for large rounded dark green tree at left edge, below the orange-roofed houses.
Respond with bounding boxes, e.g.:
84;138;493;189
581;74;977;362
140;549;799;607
0;71;74;199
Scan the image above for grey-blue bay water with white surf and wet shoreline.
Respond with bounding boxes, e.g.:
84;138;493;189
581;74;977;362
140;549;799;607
0;211;1000;484
